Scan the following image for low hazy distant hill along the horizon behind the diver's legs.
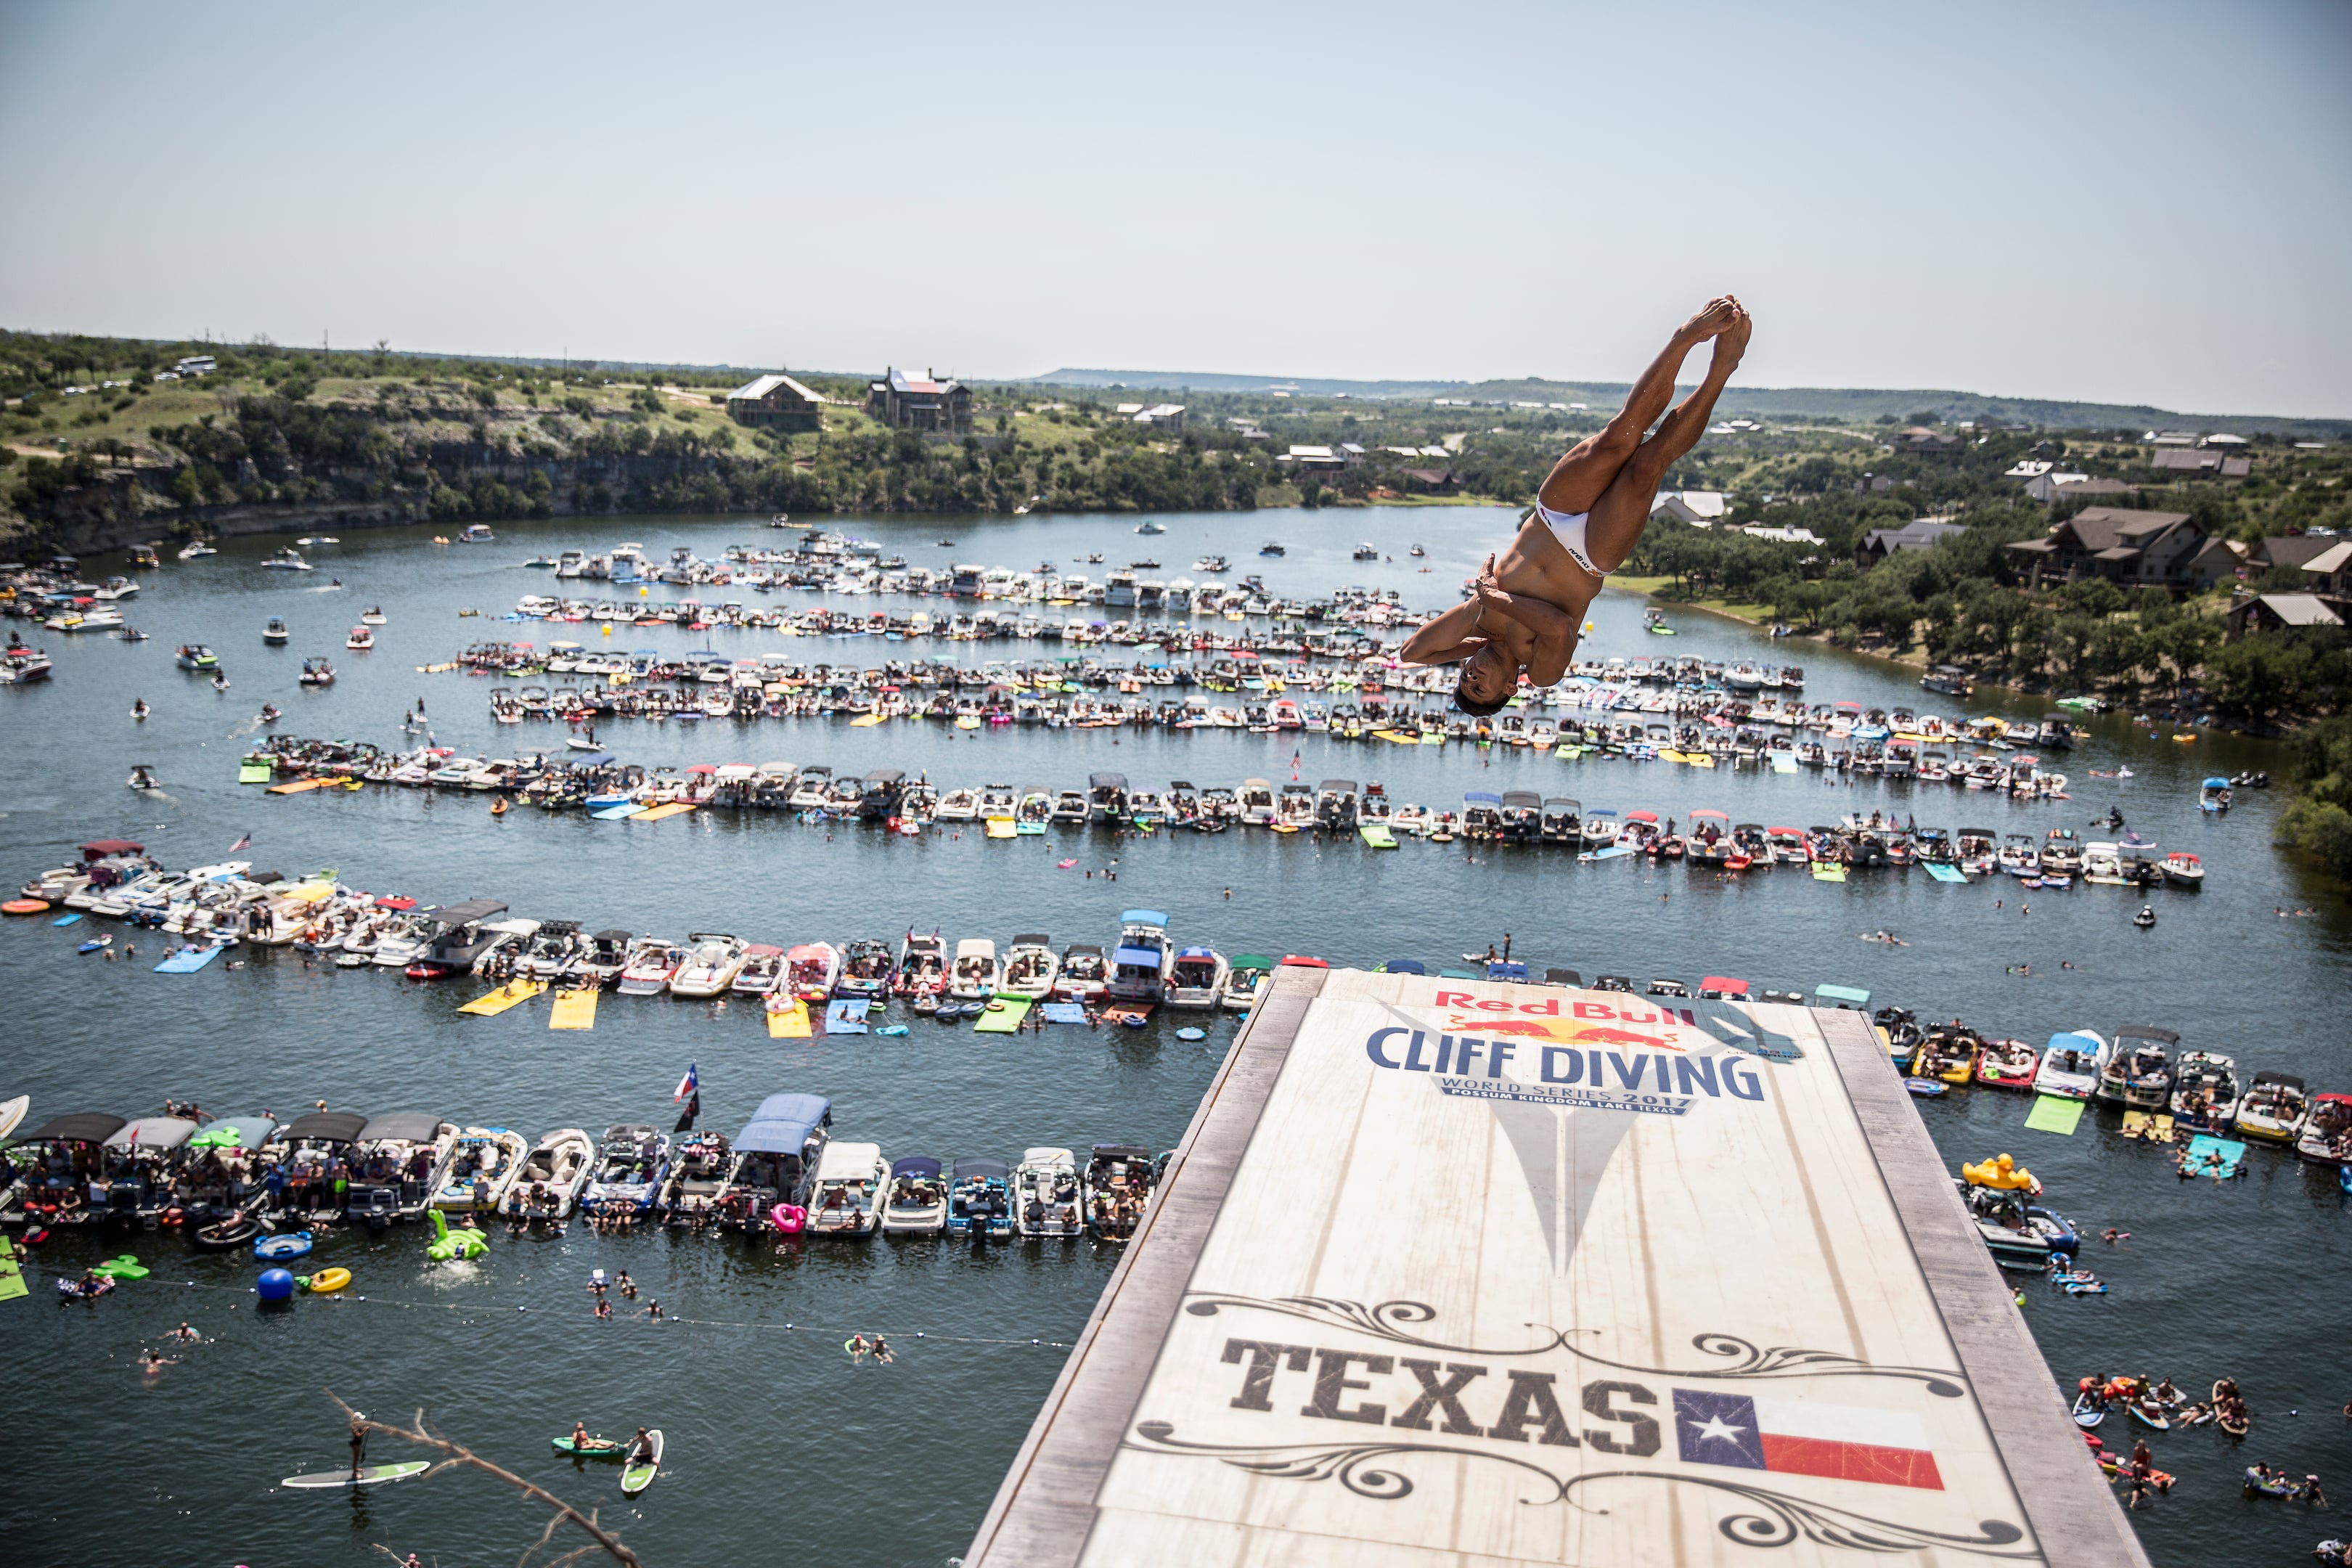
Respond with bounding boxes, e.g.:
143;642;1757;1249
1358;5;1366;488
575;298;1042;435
1028;369;2352;440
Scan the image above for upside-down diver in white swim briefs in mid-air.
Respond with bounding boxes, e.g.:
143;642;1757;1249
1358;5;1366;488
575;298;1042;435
1402;294;1752;717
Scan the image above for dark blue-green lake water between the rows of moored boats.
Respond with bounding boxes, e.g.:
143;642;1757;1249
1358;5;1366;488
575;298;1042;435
0;507;2352;1568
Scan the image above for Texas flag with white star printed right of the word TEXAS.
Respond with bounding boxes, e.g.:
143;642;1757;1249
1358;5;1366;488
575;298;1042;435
1675;1389;1943;1493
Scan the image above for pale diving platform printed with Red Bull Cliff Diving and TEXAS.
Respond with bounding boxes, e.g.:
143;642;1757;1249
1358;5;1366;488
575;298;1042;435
964;968;2147;1568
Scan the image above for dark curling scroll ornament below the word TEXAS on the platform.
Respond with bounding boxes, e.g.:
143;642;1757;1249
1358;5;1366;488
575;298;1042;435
1119;1429;2041;1561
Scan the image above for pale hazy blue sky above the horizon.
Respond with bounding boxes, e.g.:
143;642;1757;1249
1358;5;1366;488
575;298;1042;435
0;0;2352;416
